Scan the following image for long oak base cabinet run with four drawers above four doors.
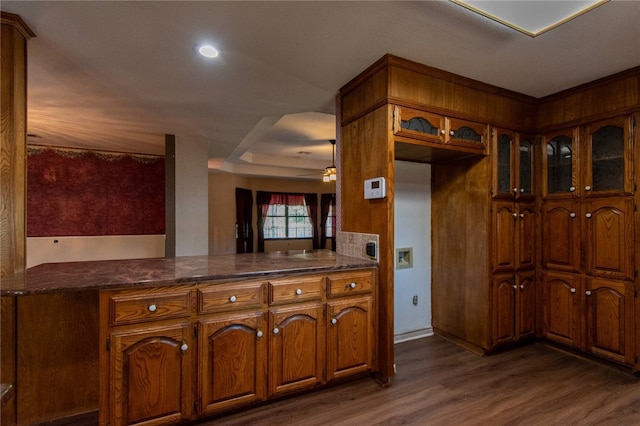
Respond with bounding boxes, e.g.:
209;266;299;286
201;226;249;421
100;269;376;425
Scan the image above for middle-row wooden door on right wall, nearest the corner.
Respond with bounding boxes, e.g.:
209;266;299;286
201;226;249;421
542;200;580;272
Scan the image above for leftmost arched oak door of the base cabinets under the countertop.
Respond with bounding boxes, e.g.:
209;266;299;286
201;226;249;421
110;322;195;426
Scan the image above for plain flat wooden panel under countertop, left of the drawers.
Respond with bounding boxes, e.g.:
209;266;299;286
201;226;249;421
16;291;99;424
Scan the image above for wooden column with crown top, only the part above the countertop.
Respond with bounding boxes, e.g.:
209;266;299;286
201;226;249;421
0;12;35;276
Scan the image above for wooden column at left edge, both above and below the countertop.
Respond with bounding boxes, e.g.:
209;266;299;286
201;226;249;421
0;11;35;425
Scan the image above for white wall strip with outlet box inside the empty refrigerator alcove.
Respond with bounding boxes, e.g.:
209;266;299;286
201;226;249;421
394;161;433;342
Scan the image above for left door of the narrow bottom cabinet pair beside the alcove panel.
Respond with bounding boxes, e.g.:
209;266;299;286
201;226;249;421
491;274;516;346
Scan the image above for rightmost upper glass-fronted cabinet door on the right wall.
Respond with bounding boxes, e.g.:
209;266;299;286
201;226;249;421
582;117;633;196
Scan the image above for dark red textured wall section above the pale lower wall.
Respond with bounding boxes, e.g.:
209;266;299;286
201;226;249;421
27;145;165;237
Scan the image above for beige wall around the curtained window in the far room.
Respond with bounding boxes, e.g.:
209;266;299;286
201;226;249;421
209;172;336;254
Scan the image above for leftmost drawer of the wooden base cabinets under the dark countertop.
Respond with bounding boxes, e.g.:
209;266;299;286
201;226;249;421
109;288;191;325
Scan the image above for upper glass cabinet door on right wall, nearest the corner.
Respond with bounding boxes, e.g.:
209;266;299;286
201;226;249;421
545;130;577;195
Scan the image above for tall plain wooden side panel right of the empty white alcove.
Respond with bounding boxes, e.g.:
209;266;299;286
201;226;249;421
431;157;490;349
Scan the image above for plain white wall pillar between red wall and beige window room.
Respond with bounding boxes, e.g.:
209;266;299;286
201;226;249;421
175;136;209;256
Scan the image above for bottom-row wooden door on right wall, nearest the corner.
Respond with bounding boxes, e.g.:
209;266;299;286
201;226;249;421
542;273;581;347
